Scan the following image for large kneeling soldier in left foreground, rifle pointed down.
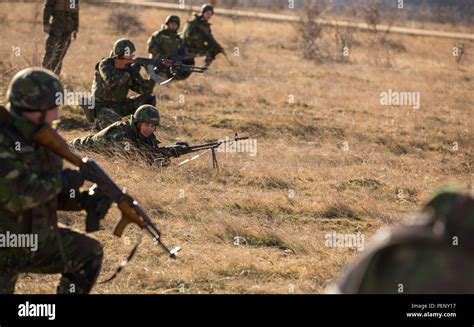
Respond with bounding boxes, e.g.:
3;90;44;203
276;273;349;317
0;68;111;294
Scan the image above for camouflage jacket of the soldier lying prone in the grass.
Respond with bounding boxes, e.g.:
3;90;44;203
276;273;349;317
70;116;169;164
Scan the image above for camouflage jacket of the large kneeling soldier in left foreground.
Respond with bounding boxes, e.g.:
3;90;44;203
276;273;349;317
0;108;81;244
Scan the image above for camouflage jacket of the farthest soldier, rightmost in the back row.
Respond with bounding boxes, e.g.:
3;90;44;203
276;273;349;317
182;14;222;52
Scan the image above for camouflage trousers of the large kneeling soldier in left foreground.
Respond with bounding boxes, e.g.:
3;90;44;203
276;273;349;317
0;228;103;294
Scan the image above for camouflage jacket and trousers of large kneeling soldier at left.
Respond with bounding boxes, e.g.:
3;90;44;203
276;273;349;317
0;109;102;294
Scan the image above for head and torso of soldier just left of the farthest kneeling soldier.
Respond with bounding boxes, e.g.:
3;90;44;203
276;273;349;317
148;16;184;59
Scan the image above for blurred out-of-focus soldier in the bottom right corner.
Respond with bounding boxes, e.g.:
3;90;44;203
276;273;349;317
327;191;474;294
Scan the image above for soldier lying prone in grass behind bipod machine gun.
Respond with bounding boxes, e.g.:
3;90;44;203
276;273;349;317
70;105;187;166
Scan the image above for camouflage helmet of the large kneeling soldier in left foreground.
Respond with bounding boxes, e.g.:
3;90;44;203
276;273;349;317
7;67;64;111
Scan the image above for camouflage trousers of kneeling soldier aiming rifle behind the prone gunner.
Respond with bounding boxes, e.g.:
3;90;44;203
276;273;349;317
95;94;156;131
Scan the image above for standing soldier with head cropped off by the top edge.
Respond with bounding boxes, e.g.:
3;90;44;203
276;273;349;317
43;0;79;75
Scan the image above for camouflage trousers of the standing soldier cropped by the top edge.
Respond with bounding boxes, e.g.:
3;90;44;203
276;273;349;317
43;31;71;75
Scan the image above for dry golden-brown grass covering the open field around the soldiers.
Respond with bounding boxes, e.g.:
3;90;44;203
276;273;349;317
0;4;474;293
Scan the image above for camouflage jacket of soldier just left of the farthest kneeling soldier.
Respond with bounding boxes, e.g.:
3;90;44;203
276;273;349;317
148;28;184;59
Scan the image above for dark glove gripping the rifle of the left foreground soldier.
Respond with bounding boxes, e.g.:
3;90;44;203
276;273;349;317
82;184;112;233
